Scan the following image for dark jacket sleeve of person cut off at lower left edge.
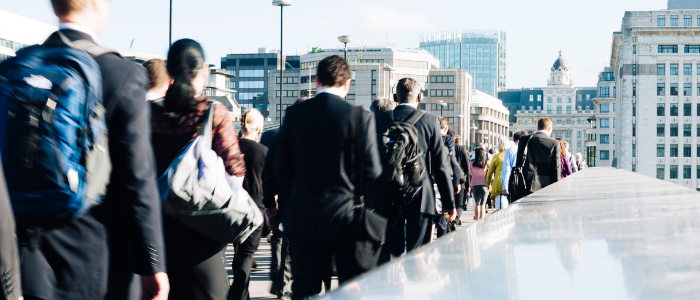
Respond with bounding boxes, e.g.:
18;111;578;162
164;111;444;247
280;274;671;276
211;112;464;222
0;155;22;300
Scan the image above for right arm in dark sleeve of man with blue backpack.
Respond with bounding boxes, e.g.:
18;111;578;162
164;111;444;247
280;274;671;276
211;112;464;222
107;67;165;275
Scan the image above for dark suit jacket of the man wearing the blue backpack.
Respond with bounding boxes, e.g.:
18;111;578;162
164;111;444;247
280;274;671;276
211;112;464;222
45;30;165;275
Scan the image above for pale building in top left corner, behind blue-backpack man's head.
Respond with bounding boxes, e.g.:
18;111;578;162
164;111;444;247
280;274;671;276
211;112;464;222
0;10;58;62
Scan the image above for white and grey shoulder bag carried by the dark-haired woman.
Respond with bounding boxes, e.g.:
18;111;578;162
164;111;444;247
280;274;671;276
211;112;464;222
158;104;263;243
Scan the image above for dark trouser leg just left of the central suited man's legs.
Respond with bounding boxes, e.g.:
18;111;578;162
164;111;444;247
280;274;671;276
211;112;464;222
270;216;292;296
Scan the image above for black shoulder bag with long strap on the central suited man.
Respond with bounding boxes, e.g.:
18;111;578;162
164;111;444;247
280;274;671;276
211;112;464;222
347;106;388;272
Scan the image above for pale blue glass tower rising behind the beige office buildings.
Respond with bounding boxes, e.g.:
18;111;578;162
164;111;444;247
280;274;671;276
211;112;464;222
420;29;506;97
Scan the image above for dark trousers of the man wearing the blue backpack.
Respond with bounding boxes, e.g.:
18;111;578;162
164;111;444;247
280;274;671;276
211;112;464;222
17;213;109;300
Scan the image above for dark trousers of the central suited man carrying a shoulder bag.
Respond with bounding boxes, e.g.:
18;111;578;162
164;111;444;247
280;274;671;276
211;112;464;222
290;234;362;299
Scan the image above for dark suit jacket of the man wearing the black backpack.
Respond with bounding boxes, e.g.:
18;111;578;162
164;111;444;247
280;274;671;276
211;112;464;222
377;105;455;215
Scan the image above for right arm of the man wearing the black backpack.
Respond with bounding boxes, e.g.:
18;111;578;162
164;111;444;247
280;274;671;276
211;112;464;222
428;118;455;210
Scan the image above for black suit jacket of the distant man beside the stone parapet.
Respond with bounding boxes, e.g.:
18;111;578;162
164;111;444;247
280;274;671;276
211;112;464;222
516;132;561;193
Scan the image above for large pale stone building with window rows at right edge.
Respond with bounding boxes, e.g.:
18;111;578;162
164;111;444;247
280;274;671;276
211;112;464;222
610;7;700;189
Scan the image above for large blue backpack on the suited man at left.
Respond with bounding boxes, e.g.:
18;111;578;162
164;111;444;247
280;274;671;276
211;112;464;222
0;32;112;224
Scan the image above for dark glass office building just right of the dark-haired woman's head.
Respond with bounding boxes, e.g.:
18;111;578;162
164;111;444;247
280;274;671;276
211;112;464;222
221;48;299;117
